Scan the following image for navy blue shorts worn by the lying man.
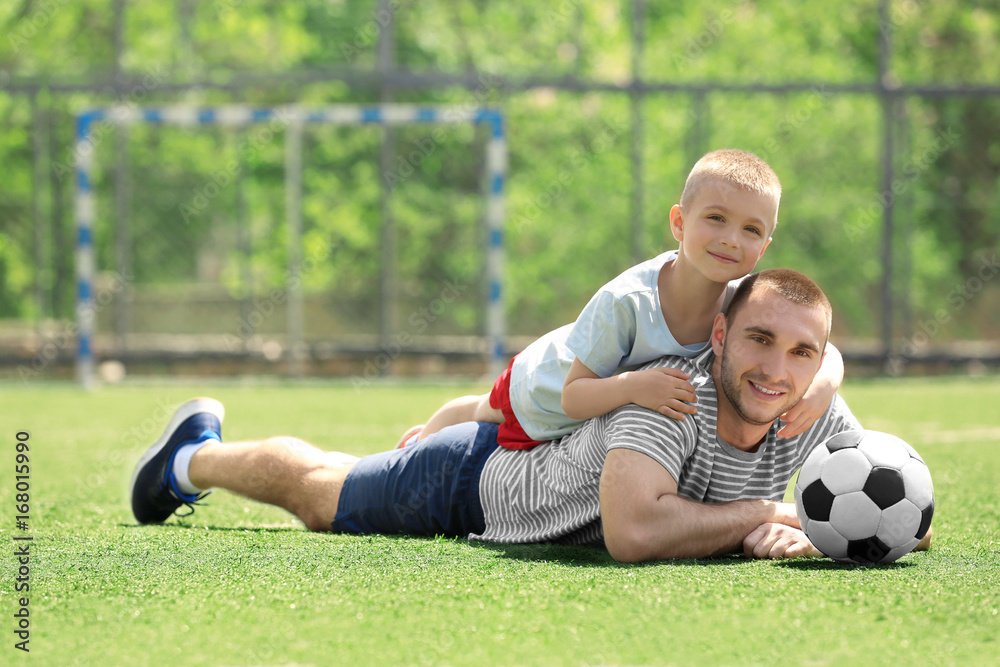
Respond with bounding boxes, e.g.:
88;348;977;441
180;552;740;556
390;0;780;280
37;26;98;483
330;423;498;537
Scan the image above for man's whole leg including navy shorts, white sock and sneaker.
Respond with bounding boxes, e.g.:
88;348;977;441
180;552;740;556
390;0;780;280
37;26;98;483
130;398;498;535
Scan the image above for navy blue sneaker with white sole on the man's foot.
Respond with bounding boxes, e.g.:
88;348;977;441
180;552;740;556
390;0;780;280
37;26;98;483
129;398;226;523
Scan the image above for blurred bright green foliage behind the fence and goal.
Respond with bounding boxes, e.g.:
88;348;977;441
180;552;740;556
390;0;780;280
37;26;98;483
0;0;1000;340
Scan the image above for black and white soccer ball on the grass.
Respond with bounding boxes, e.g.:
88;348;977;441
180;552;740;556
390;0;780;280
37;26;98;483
795;431;934;565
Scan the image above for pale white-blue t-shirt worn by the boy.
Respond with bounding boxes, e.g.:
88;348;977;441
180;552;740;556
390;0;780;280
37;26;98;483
510;250;742;440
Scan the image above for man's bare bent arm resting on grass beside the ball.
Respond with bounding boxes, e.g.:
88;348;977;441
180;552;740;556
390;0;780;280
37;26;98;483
601;449;812;562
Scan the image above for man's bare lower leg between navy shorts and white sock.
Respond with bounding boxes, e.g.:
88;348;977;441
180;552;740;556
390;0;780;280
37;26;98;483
188;437;358;531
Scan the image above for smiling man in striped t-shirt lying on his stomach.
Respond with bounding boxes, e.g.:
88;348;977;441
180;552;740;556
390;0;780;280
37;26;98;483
131;270;908;562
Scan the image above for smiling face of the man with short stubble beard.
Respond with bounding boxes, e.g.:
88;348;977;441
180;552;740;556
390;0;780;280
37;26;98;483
713;290;828;426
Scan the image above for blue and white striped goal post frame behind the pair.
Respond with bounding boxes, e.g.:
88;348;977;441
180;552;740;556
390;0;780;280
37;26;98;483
75;104;507;387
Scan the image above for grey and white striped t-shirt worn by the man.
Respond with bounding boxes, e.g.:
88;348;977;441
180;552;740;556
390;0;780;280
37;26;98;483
469;348;861;545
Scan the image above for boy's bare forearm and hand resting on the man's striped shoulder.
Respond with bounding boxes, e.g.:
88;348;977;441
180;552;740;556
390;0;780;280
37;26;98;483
562;359;696;419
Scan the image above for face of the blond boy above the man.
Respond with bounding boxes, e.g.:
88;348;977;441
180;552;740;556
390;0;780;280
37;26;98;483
670;181;778;282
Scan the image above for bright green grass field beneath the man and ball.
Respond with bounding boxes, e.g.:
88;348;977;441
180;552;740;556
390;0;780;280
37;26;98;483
0;378;1000;667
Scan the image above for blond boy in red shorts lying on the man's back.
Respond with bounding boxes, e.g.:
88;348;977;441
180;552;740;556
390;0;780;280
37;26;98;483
398;150;843;449
